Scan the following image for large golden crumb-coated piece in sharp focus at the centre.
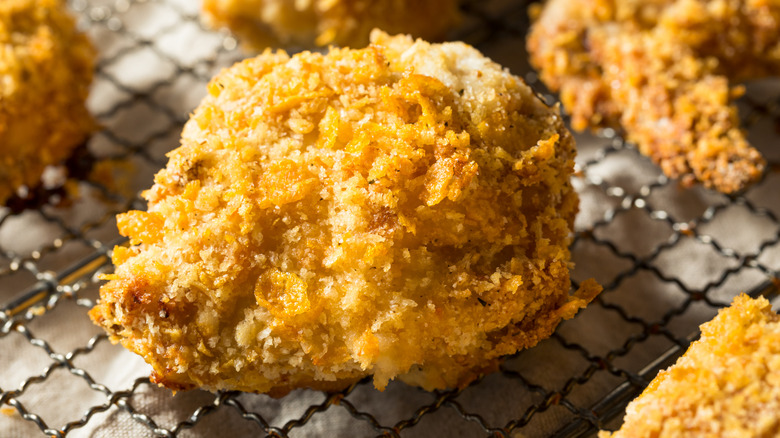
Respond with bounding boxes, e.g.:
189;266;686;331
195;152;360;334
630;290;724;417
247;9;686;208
91;32;599;395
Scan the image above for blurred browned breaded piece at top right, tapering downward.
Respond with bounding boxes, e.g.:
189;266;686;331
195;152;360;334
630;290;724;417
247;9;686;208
528;0;780;193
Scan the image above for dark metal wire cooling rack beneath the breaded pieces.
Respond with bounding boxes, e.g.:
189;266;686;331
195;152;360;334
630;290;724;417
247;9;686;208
0;0;780;437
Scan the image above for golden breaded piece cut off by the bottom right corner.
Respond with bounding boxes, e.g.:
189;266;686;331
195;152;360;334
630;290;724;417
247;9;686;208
599;294;780;438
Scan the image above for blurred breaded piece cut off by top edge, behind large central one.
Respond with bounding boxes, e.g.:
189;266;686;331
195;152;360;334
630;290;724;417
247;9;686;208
203;0;460;49
